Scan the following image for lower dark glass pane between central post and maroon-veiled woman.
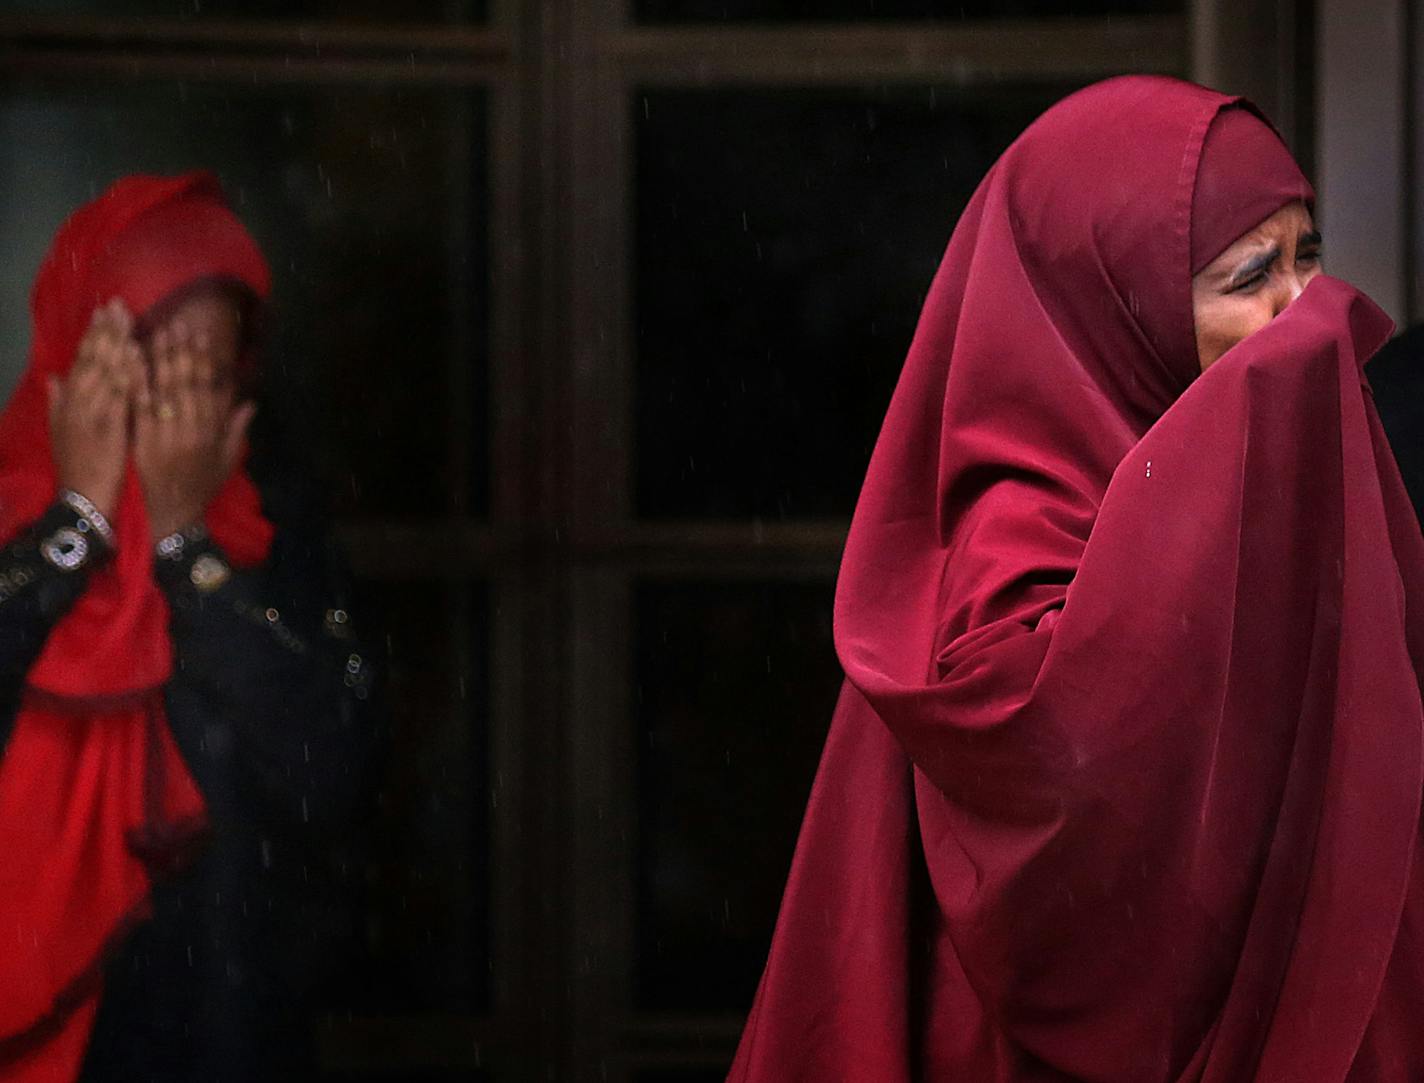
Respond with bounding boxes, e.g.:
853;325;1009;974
635;582;840;1012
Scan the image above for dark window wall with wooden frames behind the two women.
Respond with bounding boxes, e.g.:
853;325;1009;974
0;0;1406;1083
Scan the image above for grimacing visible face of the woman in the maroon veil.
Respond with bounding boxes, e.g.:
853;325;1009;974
1192;202;1320;373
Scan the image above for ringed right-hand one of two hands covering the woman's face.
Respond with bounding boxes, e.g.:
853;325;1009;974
134;320;256;541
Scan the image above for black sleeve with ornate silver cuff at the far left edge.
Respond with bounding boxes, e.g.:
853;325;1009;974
0;501;112;749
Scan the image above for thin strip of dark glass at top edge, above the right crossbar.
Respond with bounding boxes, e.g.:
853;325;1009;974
635;0;1185;23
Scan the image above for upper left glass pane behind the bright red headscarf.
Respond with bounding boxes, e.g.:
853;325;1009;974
0;81;488;517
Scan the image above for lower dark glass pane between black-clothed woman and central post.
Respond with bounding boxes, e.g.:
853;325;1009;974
320;582;491;1016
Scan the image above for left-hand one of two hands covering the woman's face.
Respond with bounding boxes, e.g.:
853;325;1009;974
47;299;144;515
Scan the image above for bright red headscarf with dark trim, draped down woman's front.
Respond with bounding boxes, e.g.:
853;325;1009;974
0;174;272;1080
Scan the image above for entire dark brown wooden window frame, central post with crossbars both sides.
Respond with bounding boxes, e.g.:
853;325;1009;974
0;0;1230;1082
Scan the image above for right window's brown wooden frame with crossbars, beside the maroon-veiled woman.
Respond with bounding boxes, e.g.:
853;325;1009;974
557;0;1189;1080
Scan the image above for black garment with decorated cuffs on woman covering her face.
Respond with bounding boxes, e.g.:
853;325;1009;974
0;472;377;1083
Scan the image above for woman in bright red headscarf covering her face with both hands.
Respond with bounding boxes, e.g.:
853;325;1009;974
0;174;372;1082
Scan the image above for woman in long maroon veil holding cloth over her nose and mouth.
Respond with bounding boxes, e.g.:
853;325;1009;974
732;77;1424;1083
